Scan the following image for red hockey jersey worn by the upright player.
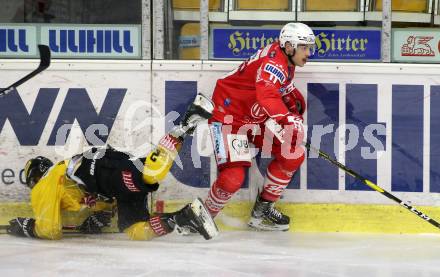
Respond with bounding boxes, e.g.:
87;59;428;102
212;42;305;125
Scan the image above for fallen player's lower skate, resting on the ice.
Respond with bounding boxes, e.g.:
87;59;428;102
162;198;218;240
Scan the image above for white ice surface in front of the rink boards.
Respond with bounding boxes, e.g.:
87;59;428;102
0;231;440;277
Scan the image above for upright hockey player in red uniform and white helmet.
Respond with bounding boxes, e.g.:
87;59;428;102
205;23;315;231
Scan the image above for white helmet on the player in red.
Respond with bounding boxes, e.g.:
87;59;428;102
279;22;315;49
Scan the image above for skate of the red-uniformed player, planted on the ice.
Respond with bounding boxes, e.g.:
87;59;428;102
248;196;290;231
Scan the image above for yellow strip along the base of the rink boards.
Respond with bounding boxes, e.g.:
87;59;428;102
0;200;440;234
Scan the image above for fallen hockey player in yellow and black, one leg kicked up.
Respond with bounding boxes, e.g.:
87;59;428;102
7;94;218;240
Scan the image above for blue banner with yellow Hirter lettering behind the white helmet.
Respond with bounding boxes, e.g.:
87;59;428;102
210;27;381;62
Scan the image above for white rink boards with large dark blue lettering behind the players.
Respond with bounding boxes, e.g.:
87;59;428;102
0;60;440;232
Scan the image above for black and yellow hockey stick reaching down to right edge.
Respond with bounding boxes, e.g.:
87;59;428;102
305;142;440;228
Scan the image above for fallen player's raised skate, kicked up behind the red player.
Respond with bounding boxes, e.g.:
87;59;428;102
171;93;214;139
